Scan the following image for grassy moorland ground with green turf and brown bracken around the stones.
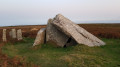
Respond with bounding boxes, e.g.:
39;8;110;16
0;24;120;67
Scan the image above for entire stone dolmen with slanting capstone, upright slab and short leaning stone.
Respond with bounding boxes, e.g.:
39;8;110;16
33;14;105;47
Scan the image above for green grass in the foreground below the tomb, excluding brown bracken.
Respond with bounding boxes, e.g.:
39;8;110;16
2;38;120;67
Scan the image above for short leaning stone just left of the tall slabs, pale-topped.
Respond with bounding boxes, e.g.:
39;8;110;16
33;28;46;46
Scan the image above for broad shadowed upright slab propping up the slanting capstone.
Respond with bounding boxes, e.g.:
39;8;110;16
46;19;76;47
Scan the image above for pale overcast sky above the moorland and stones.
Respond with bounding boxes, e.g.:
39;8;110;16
0;0;120;26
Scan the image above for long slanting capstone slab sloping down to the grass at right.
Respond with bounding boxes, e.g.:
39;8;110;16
51;14;105;47
